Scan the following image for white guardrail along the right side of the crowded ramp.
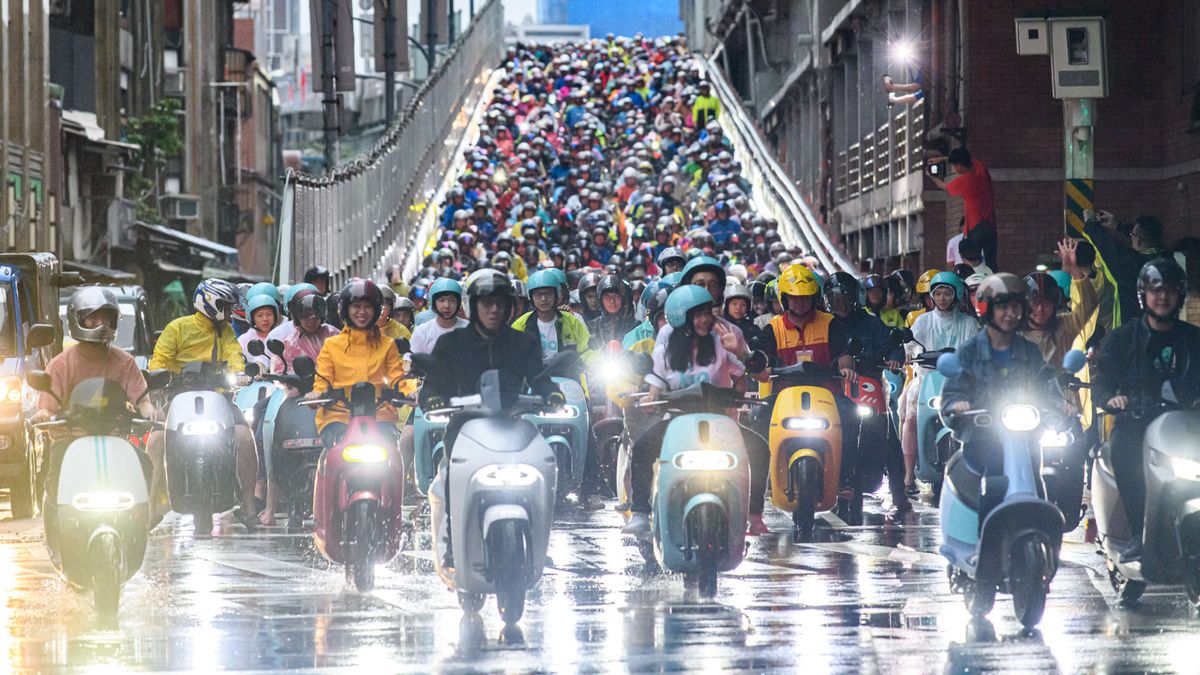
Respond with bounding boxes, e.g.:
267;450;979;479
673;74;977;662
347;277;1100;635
698;59;858;276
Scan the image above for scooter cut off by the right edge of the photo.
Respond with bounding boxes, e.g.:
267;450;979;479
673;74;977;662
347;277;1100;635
1092;383;1200;609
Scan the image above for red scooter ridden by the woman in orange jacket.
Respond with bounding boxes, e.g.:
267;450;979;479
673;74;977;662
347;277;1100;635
305;382;406;592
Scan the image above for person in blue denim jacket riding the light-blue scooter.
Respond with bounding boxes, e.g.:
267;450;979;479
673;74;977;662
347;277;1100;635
942;271;1045;476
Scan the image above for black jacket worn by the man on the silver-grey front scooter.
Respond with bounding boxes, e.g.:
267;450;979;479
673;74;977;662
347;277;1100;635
420;325;558;410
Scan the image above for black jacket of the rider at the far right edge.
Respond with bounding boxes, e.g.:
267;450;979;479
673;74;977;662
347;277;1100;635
1092;317;1200;405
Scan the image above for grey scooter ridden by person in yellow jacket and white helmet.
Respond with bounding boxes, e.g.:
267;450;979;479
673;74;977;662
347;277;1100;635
164;362;243;536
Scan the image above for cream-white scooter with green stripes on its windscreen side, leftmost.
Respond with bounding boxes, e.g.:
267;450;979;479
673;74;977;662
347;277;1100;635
26;371;169;616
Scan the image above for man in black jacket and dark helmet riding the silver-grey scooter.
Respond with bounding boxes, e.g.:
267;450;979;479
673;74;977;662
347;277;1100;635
420;269;566;568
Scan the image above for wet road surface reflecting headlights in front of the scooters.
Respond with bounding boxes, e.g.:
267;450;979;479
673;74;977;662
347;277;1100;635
0;492;1200;673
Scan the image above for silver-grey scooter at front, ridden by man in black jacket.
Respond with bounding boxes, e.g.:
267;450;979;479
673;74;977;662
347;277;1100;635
413;354;558;626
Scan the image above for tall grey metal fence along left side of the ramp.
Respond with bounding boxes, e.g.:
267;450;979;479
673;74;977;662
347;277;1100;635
276;0;504;285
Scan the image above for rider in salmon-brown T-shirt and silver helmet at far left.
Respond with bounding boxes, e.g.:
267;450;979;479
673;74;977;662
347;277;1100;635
30;286;162;555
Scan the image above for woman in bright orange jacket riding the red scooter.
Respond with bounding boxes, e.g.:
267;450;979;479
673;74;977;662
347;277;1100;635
307;279;404;448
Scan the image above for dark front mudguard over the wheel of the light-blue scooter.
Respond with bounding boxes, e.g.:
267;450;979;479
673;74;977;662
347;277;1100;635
976;498;1063;583
